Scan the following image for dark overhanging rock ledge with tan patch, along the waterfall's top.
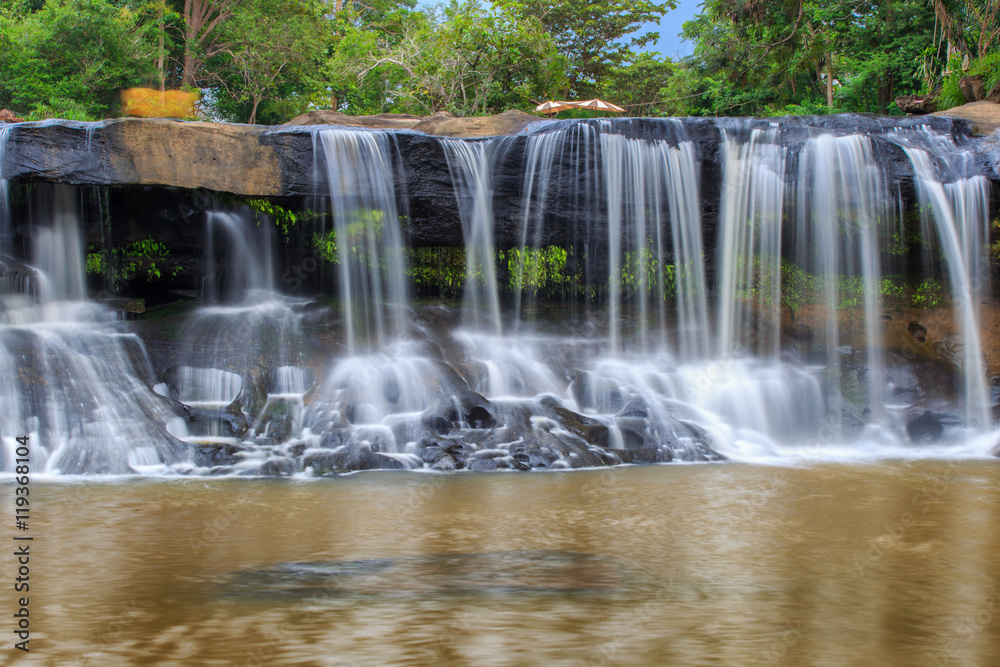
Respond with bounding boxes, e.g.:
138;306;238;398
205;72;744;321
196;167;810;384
0;113;1000;306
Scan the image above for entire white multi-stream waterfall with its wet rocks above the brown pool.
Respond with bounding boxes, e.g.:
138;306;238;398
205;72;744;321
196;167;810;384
0;118;992;475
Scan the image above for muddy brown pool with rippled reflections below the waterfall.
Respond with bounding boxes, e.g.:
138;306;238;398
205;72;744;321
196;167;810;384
0;461;1000;667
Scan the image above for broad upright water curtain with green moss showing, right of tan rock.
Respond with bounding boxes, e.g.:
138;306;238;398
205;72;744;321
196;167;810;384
319;130;408;350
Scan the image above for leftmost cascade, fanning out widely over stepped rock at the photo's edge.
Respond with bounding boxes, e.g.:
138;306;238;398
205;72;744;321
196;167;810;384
0;186;185;474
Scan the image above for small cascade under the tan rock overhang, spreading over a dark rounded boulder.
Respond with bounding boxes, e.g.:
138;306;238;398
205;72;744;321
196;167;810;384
164;209;309;460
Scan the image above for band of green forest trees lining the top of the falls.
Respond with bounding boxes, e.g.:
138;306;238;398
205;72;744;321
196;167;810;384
0;0;1000;123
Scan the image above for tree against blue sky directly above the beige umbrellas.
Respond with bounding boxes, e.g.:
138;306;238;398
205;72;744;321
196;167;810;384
498;0;677;98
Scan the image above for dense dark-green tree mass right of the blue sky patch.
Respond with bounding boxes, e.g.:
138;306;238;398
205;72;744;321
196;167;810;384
665;0;939;115
